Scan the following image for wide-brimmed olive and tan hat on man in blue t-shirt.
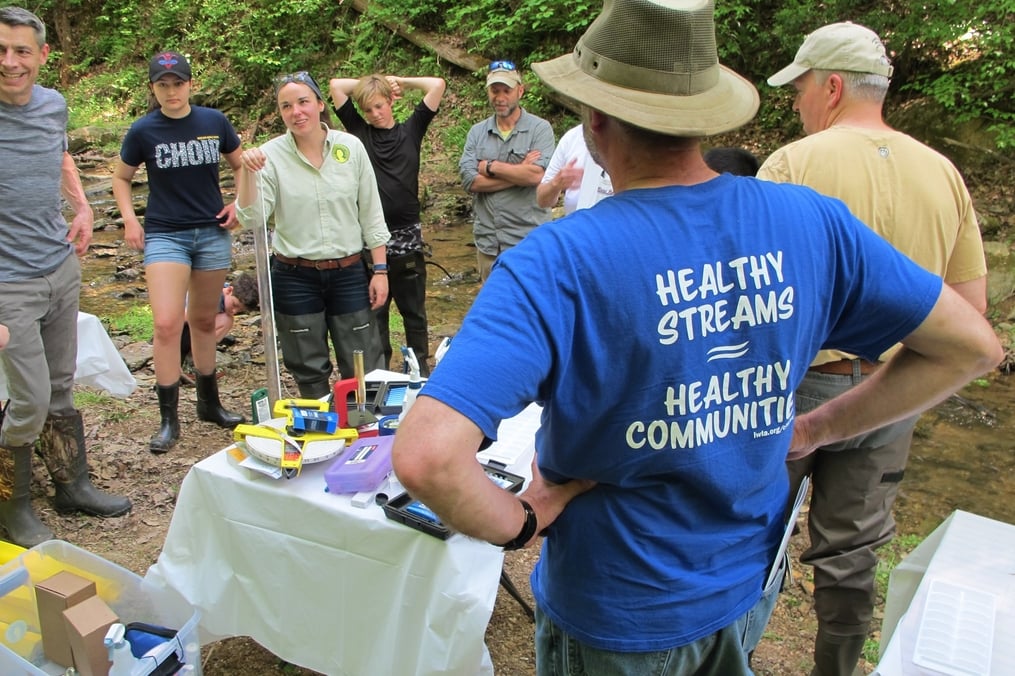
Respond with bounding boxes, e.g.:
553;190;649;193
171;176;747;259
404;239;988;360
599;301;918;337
532;0;760;137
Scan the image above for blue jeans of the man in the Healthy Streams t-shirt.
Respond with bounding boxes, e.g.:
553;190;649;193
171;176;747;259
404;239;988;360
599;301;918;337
536;607;752;676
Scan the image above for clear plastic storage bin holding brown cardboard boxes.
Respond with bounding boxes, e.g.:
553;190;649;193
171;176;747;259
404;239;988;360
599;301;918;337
0;540;201;676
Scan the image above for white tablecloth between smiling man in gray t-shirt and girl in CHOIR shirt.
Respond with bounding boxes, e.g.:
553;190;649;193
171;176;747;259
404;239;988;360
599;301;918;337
0;313;137;401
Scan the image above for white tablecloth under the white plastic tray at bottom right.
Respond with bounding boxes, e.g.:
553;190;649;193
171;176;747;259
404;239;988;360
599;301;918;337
875;511;1015;676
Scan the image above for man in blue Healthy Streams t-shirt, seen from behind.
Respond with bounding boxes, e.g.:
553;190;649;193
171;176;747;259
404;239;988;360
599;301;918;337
393;0;1002;676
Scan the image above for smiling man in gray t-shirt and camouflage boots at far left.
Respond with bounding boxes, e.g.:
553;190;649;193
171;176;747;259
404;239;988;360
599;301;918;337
0;7;131;547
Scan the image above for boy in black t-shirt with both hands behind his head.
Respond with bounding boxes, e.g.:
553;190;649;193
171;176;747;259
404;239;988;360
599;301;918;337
330;74;446;377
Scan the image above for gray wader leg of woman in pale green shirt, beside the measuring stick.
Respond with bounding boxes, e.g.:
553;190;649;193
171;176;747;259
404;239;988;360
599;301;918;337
275;313;334;399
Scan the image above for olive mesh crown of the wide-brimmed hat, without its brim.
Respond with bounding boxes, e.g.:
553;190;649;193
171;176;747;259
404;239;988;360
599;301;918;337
574;2;719;96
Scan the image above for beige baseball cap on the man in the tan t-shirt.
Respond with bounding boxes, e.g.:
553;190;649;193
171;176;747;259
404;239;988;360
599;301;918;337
768;21;892;87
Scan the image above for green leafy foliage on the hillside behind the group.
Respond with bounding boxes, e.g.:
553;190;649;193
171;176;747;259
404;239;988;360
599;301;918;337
33;0;1015;149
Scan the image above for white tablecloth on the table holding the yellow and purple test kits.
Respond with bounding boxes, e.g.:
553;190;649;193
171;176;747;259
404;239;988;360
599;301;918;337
145;371;539;676
